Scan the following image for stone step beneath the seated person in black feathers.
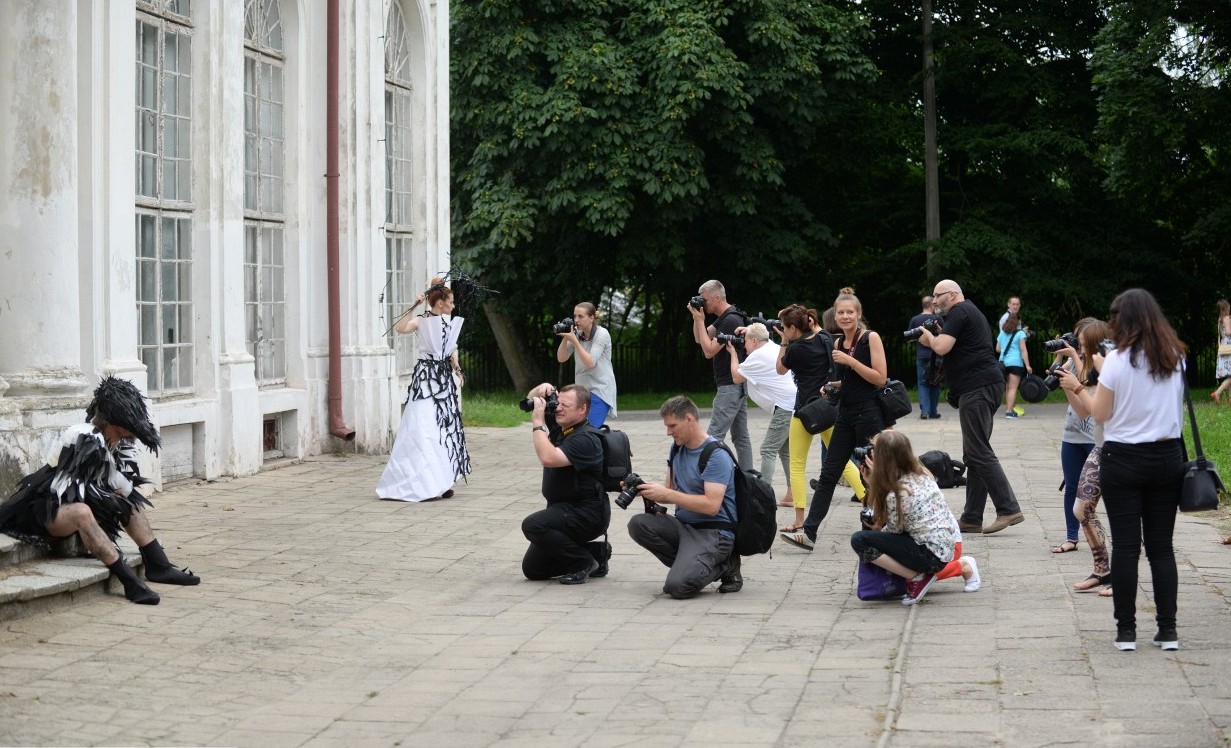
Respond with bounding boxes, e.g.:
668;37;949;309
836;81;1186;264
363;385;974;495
0;535;142;621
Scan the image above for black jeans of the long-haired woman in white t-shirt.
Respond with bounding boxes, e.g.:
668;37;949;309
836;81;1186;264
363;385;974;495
1099;439;1184;631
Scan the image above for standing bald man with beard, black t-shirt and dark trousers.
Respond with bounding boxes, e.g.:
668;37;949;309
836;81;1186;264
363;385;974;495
920;281;1025;534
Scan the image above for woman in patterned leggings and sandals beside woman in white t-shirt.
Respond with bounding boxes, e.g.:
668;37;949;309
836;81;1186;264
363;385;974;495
1053;317;1112;598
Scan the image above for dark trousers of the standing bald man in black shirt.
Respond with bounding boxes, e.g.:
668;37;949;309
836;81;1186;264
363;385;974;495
958;381;1022;525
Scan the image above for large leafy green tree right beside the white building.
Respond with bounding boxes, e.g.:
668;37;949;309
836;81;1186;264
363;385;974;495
452;0;874;386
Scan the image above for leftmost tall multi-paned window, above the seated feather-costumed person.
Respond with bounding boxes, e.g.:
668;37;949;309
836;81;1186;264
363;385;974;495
135;0;193;396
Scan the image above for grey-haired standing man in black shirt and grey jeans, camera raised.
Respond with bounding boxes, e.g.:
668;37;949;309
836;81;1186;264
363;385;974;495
688;281;752;466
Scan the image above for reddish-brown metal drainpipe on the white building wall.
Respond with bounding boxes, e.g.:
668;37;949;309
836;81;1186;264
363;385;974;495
325;0;355;442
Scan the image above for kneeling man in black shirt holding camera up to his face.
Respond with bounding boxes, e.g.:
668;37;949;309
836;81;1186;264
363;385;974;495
522;383;612;584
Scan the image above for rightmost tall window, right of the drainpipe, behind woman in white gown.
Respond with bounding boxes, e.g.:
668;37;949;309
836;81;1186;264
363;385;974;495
385;0;417;372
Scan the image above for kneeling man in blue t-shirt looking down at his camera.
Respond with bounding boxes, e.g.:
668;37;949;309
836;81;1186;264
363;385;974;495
628;395;744;600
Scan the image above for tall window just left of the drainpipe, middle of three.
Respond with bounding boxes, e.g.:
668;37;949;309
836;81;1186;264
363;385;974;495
244;0;287;385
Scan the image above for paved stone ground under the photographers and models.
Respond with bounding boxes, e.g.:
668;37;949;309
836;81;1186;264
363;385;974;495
0;406;1231;748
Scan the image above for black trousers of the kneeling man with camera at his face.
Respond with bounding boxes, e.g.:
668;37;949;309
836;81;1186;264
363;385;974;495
522;501;611;579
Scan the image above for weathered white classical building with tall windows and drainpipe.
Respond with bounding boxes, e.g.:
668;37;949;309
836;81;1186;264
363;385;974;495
0;0;449;487
